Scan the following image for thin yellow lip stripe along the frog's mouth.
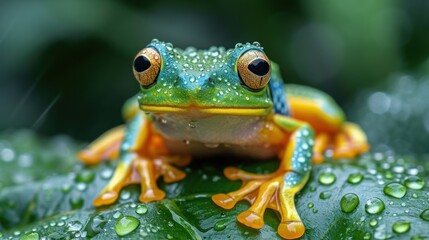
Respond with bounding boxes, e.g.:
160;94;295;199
140;105;270;116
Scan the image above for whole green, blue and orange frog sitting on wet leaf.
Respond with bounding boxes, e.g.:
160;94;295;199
78;39;369;239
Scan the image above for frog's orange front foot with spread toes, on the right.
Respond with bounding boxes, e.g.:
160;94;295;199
212;167;308;239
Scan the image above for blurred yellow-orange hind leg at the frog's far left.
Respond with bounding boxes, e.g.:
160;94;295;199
77;126;125;164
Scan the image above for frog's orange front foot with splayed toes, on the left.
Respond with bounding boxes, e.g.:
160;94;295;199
94;156;191;207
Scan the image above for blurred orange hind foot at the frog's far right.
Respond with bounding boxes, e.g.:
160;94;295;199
313;122;369;163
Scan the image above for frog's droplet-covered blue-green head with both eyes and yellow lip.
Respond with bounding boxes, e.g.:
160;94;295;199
133;40;273;116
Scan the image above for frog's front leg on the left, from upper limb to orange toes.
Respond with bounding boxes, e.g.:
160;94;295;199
94;113;190;206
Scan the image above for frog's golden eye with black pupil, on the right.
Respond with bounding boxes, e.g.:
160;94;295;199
237;50;271;90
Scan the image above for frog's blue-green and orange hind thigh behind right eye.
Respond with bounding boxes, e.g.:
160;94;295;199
285;84;345;133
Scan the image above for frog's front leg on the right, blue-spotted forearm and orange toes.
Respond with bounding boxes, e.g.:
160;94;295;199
212;115;314;239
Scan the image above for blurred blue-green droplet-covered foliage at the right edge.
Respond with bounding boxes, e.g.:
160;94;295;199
349;71;429;156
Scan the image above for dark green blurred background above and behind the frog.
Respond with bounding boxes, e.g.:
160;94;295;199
0;0;429;149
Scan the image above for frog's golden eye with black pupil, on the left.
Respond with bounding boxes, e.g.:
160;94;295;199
133;47;161;87
